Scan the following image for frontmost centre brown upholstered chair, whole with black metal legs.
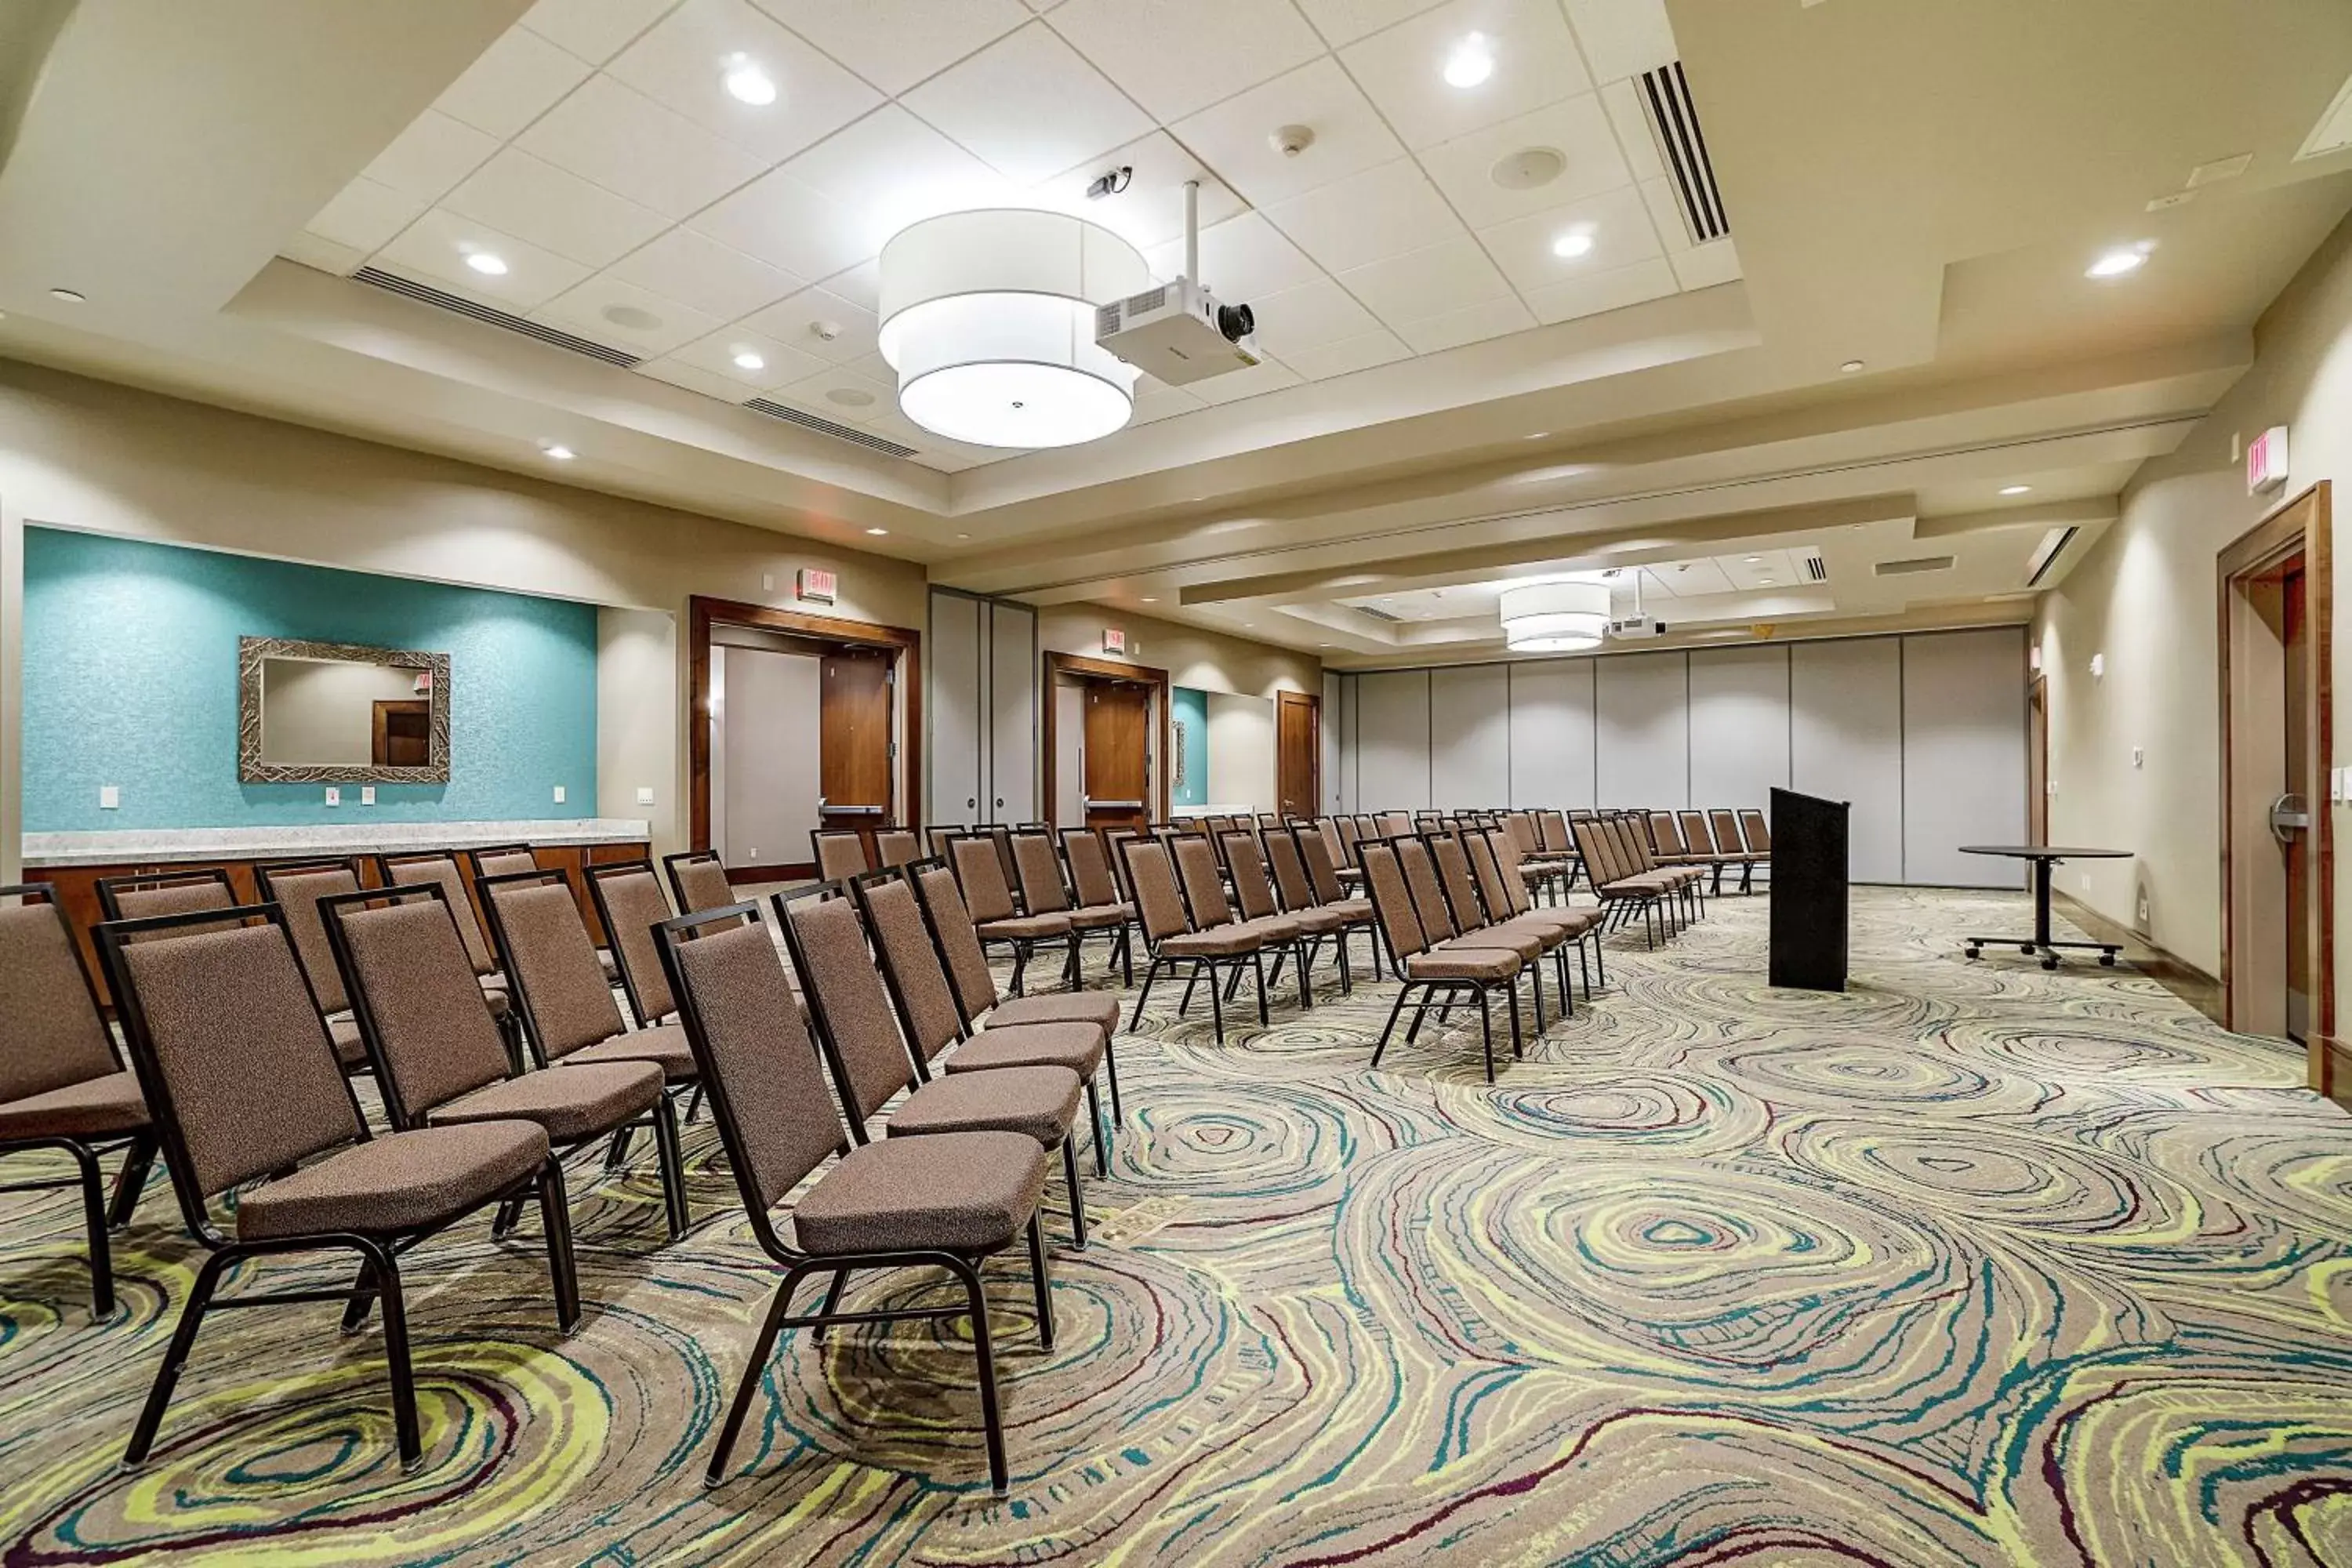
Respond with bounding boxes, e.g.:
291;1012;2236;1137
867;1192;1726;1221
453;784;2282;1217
661;902;1054;1495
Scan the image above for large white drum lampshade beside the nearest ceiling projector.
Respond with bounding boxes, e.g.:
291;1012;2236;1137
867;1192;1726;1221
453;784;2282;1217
882;207;1150;447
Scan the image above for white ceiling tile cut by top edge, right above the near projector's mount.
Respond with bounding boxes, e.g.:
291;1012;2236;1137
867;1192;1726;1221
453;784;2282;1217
1047;0;1324;129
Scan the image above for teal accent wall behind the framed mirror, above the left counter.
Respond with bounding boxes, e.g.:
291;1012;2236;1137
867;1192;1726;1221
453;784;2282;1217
24;529;595;832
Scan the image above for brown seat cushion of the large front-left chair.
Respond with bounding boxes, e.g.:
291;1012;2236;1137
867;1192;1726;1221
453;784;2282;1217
238;1121;548;1241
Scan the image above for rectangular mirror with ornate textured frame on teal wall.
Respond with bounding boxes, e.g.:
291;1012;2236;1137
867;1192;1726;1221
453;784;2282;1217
238;637;449;783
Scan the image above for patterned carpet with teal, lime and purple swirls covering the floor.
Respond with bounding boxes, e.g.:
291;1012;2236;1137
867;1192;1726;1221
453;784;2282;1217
0;891;2352;1568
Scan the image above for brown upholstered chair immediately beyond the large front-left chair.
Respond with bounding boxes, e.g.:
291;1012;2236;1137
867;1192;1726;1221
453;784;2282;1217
320;872;687;1241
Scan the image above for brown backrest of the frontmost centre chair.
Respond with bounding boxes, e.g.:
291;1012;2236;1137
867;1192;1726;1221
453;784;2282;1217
661;902;842;1222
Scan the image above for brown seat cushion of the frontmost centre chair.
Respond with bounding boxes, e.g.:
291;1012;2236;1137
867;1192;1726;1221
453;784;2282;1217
793;1133;1044;1258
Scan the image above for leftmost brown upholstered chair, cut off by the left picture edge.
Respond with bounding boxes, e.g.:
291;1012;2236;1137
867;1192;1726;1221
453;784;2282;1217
0;884;155;1319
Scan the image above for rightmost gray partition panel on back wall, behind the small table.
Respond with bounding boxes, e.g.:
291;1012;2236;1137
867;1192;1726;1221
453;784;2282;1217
1903;626;2025;888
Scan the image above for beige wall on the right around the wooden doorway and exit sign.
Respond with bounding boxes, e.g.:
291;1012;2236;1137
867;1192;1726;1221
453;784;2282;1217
2034;211;2352;996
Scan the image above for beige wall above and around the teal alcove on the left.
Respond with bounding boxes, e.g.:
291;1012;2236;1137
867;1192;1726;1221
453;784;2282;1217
0;362;924;879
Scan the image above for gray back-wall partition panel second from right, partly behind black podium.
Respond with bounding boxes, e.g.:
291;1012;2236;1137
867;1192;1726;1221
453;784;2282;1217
1788;637;1903;881
